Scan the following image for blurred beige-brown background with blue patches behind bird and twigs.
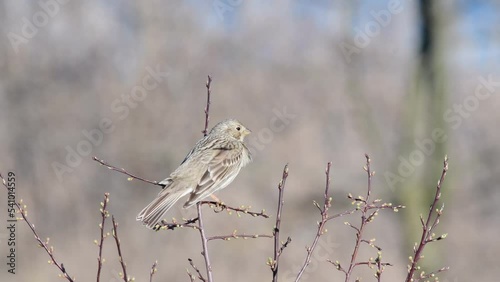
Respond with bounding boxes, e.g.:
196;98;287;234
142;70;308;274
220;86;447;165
0;0;500;282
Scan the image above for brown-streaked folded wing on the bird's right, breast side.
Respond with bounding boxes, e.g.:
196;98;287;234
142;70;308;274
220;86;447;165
186;147;244;205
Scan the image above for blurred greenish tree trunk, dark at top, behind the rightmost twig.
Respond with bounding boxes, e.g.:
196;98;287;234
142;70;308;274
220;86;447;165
396;0;450;270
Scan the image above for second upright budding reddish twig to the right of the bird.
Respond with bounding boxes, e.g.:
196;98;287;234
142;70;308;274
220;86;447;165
295;162;332;282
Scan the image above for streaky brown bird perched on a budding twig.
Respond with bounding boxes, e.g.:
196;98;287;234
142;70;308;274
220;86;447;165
136;119;252;229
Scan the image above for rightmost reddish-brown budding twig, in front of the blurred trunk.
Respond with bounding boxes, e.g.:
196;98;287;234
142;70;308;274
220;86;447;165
405;156;448;282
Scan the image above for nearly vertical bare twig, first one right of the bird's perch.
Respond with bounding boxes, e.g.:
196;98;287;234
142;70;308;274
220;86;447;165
268;164;292;282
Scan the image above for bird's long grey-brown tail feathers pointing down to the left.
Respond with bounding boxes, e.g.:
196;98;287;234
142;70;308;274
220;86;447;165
136;183;190;228
